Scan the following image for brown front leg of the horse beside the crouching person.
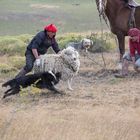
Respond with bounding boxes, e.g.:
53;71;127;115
117;33;125;62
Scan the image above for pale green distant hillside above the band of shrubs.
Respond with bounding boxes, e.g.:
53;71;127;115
0;0;103;35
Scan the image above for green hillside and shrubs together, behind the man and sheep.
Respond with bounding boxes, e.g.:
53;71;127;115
0;0;137;73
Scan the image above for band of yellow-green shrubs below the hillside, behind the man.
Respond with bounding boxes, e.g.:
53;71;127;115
0;33;115;75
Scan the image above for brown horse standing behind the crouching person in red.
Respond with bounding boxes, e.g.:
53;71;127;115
96;0;140;60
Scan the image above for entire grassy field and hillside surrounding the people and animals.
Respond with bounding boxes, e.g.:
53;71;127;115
0;0;140;140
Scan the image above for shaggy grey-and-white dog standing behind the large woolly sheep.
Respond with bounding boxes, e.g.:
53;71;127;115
66;38;93;52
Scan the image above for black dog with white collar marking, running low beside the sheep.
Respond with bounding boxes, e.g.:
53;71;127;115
2;72;61;98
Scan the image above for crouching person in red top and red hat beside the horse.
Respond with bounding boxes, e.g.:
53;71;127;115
115;28;140;78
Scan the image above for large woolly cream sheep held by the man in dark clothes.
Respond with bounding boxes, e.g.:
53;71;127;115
33;46;80;90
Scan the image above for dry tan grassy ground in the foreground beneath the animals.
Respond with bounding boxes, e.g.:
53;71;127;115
0;53;140;140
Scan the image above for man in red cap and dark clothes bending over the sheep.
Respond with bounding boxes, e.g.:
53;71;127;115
16;24;60;78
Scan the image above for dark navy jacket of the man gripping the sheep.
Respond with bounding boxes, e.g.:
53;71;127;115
25;31;60;55
